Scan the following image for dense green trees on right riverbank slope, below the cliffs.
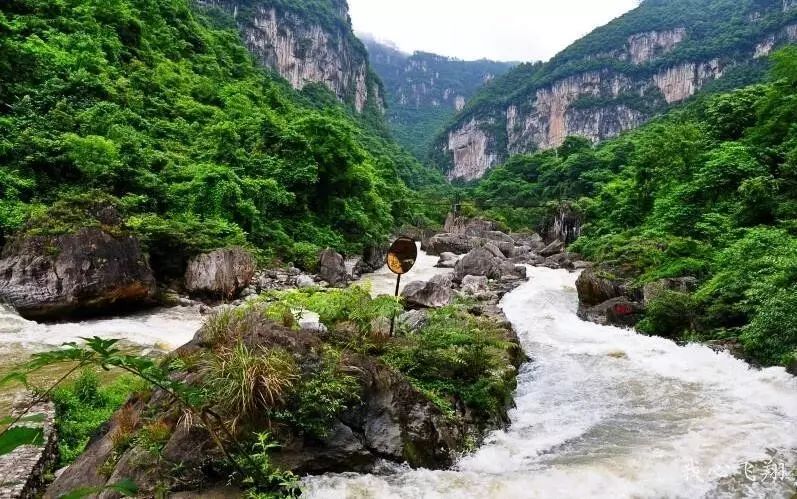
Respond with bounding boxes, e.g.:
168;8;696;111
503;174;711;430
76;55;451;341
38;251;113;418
470;48;797;365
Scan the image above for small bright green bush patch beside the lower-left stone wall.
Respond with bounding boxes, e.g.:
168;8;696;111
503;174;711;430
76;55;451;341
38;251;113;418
51;368;147;468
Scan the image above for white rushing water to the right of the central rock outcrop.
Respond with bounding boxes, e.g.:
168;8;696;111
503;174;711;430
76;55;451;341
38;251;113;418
304;268;797;499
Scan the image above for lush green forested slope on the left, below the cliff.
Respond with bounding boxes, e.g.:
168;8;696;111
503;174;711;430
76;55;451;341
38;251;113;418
0;0;436;280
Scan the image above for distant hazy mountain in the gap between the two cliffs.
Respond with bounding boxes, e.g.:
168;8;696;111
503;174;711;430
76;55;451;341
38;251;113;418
362;36;516;159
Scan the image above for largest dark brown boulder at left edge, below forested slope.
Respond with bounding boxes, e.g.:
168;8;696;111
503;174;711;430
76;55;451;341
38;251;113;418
0;228;157;320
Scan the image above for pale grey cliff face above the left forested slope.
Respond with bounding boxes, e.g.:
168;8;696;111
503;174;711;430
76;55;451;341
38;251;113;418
199;0;384;112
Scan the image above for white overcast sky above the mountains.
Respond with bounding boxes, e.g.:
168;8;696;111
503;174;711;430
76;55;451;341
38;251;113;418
349;0;639;61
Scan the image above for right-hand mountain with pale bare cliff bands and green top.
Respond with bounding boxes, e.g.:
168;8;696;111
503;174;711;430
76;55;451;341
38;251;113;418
432;0;797;180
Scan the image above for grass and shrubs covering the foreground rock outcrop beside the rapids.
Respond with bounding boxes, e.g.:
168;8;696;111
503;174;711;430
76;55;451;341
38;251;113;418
0;286;521;497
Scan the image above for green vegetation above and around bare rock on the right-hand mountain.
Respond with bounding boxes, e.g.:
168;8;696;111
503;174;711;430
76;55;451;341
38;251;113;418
436;0;797;169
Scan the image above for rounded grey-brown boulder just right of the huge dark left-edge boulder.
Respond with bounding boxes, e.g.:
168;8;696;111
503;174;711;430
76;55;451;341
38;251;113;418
185;246;256;299
